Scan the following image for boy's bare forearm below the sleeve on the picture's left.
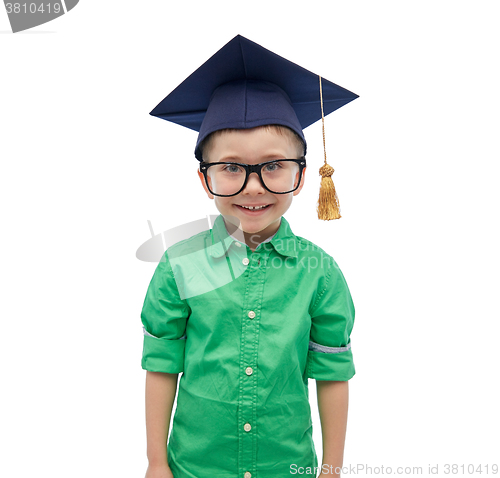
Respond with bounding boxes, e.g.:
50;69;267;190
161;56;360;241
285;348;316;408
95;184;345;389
146;371;178;466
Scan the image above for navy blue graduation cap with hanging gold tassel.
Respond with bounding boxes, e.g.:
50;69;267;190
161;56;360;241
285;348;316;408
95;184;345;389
150;35;358;220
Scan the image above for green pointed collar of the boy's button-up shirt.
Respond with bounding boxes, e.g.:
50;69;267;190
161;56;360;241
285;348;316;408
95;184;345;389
210;214;298;257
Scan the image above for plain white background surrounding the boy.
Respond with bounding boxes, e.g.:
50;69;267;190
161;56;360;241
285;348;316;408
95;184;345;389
0;0;500;478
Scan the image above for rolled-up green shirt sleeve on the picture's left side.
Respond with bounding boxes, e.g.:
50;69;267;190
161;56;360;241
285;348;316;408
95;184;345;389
141;253;190;373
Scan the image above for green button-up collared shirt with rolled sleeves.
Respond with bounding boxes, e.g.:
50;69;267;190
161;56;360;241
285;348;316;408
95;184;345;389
141;215;355;478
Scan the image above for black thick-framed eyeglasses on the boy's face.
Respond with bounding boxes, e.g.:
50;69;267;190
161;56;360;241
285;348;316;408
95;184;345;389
200;157;306;197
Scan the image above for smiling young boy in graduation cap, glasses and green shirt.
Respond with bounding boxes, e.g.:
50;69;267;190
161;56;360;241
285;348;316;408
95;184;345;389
141;36;356;478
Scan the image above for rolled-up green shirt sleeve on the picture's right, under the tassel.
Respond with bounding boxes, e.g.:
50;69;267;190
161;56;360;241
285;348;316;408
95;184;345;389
306;258;355;381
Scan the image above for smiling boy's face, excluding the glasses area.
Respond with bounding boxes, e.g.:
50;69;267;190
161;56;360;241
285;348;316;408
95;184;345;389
198;128;305;240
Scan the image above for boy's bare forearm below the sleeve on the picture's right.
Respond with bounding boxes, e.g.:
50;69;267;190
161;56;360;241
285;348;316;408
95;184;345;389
316;380;349;477
